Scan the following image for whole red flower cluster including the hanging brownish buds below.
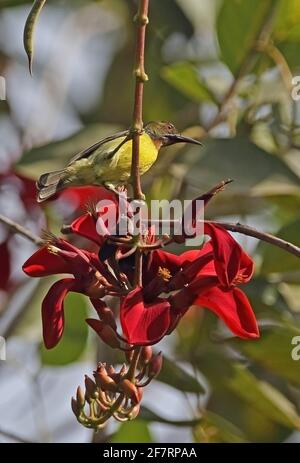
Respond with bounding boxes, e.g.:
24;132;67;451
23;186;259;429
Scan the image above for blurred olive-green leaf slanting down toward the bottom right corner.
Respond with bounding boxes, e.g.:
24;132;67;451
226;366;300;429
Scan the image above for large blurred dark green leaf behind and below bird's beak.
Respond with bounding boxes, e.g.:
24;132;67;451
178;135;300;196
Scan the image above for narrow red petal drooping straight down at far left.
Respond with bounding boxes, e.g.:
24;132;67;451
42;278;78;349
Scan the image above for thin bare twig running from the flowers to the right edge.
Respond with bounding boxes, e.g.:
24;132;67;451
207;220;300;257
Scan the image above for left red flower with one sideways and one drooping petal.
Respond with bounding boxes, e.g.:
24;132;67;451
23;238;117;349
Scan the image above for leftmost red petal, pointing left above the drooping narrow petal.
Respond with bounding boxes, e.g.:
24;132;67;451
22;247;72;277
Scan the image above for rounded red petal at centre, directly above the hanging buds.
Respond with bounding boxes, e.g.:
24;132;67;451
120;288;171;345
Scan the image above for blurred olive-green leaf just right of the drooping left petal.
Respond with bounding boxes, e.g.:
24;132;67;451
40;293;88;365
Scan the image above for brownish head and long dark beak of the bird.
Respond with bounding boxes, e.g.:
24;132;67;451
145;121;202;146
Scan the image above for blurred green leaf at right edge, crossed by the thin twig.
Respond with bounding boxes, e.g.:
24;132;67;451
258;219;300;274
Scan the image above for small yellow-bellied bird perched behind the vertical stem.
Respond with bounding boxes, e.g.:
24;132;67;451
37;122;201;202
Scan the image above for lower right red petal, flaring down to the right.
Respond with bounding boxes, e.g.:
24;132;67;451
194;287;259;339
